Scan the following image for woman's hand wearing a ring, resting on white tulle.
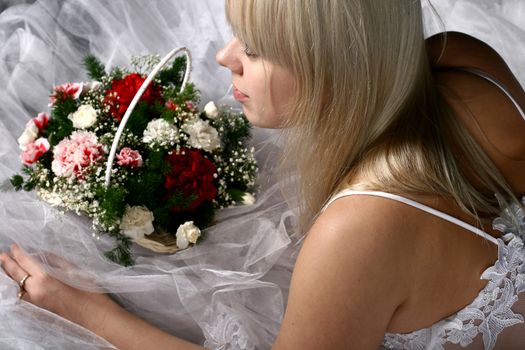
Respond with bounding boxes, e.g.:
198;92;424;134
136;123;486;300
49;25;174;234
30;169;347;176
0;244;109;321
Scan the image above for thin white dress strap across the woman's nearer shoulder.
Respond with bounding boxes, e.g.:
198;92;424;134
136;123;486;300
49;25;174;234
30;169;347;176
323;189;498;245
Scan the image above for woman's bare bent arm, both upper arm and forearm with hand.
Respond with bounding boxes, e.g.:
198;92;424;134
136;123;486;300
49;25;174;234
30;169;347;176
0;197;410;350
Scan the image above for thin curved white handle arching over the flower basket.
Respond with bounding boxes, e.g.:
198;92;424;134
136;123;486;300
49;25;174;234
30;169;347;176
104;47;191;188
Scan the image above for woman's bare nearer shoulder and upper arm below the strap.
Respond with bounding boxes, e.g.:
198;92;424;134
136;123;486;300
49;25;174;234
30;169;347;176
274;196;412;349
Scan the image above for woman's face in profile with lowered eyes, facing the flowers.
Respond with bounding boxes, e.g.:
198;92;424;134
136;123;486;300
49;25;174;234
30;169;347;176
216;38;294;128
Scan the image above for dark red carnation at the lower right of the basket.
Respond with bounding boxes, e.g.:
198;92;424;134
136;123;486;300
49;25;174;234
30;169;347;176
164;148;217;212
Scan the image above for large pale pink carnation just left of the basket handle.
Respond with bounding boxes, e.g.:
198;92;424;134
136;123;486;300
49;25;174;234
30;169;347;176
51;131;104;180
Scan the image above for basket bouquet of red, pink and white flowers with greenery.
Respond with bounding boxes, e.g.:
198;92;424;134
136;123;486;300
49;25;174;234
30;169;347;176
11;48;257;265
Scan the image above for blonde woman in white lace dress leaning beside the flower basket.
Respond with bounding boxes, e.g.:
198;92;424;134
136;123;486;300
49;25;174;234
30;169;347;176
0;0;525;349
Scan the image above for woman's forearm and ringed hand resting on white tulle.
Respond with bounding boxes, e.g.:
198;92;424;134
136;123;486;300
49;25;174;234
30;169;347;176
0;245;204;350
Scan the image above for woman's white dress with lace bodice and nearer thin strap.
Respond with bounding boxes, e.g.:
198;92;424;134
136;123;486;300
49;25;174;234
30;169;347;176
328;190;525;350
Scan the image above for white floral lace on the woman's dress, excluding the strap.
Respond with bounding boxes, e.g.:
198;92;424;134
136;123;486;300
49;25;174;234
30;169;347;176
381;198;525;349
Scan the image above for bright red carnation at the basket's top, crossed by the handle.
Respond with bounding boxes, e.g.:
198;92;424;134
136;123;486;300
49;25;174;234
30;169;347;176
104;73;161;121
